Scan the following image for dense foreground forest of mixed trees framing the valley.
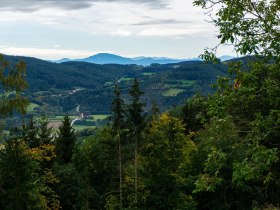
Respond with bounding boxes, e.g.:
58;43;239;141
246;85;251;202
0;0;280;210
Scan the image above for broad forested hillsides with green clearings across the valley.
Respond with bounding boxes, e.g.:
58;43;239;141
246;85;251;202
2;56;227;113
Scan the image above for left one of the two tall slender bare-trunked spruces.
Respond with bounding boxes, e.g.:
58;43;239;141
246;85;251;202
111;85;124;209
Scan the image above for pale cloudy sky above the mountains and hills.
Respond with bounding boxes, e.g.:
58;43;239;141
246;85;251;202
0;0;235;60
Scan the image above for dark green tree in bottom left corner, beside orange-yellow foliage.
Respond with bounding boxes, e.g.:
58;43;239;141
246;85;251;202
0;138;46;210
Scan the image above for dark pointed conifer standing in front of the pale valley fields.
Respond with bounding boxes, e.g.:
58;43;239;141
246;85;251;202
56;116;76;164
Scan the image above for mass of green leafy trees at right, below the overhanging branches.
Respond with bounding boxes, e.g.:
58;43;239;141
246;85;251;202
188;62;280;209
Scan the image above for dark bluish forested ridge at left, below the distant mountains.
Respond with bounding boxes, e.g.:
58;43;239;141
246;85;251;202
2;56;142;91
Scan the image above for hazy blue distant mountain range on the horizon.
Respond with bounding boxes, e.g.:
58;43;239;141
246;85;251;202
53;53;234;66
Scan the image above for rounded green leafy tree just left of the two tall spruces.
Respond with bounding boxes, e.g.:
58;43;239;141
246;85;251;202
74;126;120;209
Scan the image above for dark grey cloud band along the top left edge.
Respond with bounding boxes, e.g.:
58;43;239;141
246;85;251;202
0;0;168;11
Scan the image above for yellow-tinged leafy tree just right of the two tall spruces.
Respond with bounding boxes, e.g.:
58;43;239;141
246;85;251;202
140;113;195;209
